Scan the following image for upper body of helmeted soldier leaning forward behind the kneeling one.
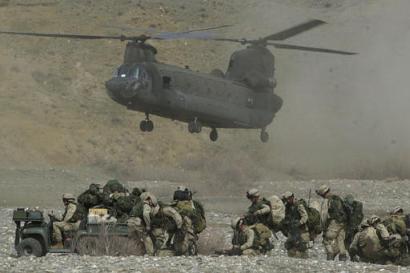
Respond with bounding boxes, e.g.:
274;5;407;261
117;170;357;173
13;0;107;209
245;189;271;226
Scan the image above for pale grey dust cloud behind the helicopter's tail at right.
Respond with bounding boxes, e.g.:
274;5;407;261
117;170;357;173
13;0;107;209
227;0;410;179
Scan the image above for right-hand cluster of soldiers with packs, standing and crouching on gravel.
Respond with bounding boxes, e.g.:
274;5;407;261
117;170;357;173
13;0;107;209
225;185;410;265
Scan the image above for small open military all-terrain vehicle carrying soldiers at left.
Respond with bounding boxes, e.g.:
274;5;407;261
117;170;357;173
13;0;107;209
13;208;197;257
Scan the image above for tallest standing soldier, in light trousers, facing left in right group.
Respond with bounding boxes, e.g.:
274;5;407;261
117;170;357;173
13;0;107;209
316;185;347;261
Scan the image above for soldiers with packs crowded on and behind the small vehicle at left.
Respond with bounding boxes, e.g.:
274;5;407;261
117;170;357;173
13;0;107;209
49;180;206;255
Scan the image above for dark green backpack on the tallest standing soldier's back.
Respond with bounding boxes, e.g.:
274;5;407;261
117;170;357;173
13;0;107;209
343;194;364;233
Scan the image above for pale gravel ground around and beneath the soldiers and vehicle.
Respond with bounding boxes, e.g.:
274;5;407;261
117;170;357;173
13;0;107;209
0;174;410;273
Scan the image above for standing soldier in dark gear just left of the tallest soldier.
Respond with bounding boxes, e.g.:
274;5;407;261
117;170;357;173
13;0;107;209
282;192;310;258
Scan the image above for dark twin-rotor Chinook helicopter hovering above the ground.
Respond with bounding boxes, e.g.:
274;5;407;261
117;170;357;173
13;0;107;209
0;20;355;142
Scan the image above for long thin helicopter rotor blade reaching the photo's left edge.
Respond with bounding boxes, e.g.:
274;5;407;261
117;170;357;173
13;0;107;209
0;31;138;41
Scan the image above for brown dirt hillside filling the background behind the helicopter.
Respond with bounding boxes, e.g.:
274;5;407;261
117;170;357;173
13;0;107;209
0;0;409;185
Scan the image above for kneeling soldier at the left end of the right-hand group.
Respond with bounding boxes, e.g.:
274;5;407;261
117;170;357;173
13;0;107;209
231;218;272;256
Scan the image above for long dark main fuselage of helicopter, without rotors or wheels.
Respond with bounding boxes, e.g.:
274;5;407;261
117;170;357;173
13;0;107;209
106;62;277;129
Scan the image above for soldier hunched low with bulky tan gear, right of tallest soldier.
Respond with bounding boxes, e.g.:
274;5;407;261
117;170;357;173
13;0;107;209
349;215;400;264
